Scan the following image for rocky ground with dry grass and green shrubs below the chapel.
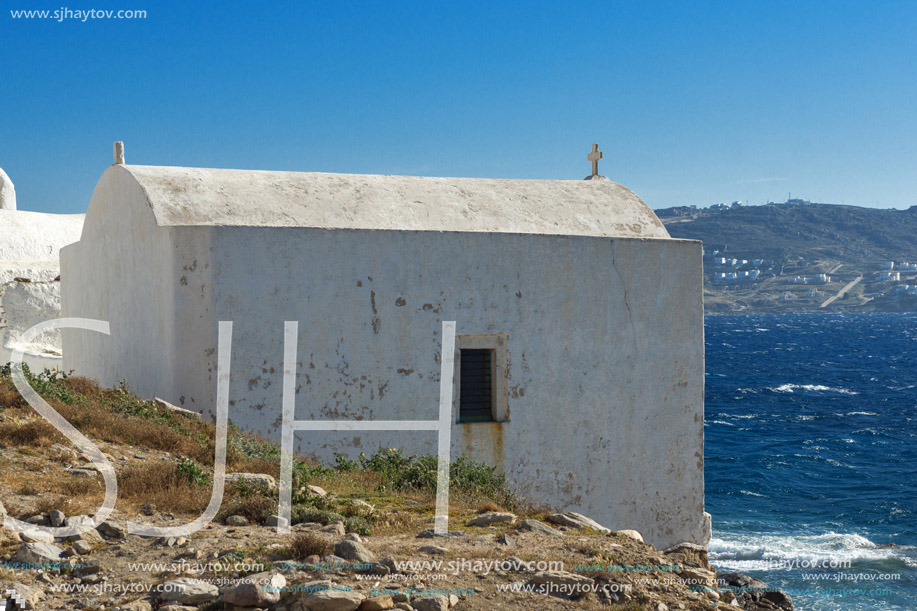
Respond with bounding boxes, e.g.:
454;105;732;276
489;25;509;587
0;370;792;611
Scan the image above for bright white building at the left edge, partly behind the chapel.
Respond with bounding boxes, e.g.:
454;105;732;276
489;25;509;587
0;169;83;370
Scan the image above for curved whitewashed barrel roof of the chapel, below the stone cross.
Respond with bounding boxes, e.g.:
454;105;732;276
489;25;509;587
118;165;669;238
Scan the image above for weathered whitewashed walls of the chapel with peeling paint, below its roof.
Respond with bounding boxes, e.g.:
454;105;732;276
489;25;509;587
62;164;709;546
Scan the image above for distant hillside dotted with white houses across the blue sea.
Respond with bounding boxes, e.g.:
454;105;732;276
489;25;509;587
656;200;917;313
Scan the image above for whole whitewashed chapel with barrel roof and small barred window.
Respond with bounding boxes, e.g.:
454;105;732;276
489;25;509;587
61;160;710;546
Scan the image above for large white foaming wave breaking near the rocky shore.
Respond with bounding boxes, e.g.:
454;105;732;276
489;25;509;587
707;532;903;572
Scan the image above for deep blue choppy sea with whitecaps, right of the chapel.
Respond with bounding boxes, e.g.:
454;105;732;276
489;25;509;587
705;314;917;611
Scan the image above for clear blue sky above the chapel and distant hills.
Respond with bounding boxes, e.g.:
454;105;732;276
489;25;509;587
0;0;917;212
